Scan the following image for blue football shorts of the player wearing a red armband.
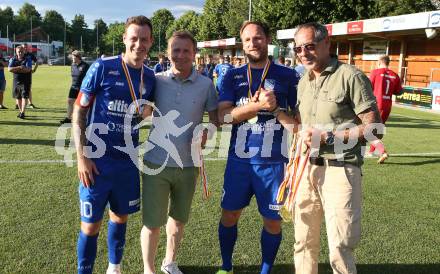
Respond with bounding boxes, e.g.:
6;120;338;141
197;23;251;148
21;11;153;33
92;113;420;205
79;159;140;223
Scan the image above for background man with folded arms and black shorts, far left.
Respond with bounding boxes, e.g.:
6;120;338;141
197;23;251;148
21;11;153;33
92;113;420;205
8;46;32;119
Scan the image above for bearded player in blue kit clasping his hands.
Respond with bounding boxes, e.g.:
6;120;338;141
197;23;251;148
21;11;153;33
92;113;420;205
217;21;298;274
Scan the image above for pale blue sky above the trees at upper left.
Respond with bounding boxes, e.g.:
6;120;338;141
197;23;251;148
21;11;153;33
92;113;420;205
0;0;205;28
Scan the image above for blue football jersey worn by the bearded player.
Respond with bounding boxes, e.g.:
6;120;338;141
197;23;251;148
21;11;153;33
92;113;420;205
219;63;299;164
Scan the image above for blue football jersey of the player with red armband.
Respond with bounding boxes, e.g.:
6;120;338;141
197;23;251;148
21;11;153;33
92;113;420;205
78;55;156;159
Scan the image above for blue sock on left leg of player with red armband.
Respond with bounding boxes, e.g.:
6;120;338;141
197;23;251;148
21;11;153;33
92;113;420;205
77;231;99;274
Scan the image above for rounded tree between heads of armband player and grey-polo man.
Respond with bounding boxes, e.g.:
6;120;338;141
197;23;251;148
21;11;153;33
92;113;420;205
150;9;174;52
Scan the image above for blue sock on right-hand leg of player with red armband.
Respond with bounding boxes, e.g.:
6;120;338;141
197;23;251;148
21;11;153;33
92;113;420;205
107;220;127;264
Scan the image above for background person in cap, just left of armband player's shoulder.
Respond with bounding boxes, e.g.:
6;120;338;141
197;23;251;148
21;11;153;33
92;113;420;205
60;50;90;124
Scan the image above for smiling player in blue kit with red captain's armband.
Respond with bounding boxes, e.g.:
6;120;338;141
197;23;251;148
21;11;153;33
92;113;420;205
72;16;155;274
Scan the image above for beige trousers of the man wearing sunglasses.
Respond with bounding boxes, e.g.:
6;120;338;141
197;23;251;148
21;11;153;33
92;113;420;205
294;161;362;274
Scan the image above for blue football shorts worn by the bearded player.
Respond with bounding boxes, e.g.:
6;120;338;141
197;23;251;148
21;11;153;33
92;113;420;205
221;160;285;220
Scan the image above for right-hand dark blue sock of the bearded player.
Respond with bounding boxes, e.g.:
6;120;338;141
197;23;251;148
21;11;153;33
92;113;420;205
261;228;283;274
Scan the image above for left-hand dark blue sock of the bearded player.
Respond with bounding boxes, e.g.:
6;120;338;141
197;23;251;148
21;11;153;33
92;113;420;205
218;222;237;271
